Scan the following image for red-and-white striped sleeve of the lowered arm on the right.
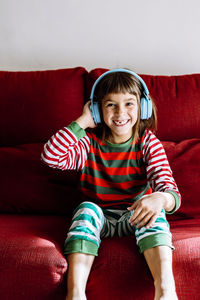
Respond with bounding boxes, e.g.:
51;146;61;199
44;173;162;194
143;131;181;213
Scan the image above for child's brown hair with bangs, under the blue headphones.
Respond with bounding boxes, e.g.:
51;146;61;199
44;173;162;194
94;72;157;142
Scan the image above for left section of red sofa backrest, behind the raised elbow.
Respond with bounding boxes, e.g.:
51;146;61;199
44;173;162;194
0;67;88;214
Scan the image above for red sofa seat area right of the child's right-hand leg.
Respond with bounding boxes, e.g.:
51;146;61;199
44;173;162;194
170;219;200;300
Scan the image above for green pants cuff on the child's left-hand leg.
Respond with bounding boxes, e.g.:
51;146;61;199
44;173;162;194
64;240;98;256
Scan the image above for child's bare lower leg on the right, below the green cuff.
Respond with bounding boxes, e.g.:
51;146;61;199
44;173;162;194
144;246;178;300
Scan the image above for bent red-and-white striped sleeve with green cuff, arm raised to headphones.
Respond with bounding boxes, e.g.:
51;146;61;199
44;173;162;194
41;122;90;170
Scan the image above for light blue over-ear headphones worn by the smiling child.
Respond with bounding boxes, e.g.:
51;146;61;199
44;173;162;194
90;69;152;124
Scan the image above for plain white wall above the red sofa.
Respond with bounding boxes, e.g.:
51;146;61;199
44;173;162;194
0;0;200;75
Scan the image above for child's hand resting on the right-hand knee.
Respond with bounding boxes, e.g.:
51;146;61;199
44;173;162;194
128;192;168;228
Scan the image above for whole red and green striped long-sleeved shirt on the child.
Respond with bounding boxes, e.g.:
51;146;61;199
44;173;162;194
42;122;180;213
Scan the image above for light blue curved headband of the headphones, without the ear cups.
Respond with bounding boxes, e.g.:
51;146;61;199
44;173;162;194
90;69;149;100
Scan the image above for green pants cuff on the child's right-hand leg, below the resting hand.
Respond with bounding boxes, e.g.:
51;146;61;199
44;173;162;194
138;233;175;253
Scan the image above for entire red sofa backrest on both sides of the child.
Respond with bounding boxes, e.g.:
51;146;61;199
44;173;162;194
0;68;200;218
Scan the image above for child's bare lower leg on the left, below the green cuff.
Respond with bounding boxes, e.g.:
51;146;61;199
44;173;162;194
66;253;95;300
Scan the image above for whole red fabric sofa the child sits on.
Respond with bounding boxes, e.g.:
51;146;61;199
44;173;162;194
0;68;200;300
